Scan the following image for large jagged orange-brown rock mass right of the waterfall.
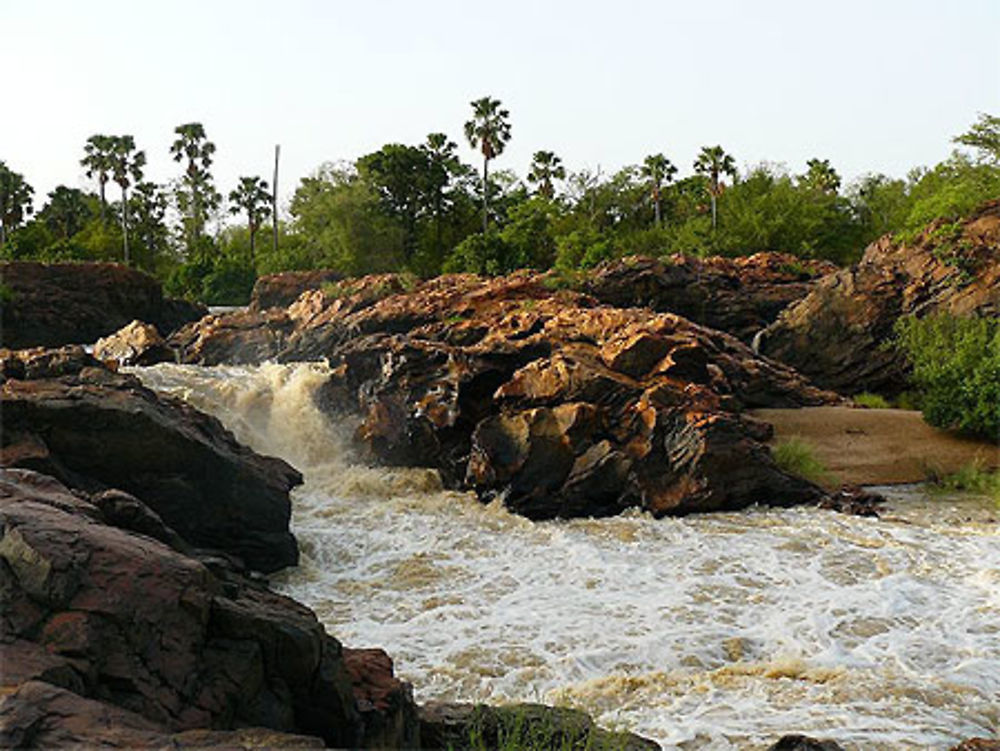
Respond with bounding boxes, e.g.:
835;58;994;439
174;273;838;518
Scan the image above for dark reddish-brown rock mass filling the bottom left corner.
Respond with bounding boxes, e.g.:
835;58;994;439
0;469;418;748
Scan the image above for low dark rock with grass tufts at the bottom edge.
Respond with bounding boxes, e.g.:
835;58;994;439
420;702;660;751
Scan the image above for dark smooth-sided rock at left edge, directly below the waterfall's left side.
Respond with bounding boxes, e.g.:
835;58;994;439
0;347;301;571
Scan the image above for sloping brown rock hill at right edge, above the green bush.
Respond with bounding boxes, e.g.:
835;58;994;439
760;201;1000;394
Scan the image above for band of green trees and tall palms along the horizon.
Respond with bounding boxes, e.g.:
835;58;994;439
0;110;1000;303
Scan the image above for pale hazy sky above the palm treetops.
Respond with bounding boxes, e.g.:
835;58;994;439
0;0;1000;213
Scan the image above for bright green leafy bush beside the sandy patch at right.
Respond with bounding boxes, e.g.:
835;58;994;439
896;316;1000;439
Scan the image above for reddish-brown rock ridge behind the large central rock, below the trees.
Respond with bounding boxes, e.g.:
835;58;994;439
580;253;837;343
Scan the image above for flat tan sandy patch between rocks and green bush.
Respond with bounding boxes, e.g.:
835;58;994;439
749;406;1000;485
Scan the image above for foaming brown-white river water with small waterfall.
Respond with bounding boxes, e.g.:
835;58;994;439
138;364;1000;749
